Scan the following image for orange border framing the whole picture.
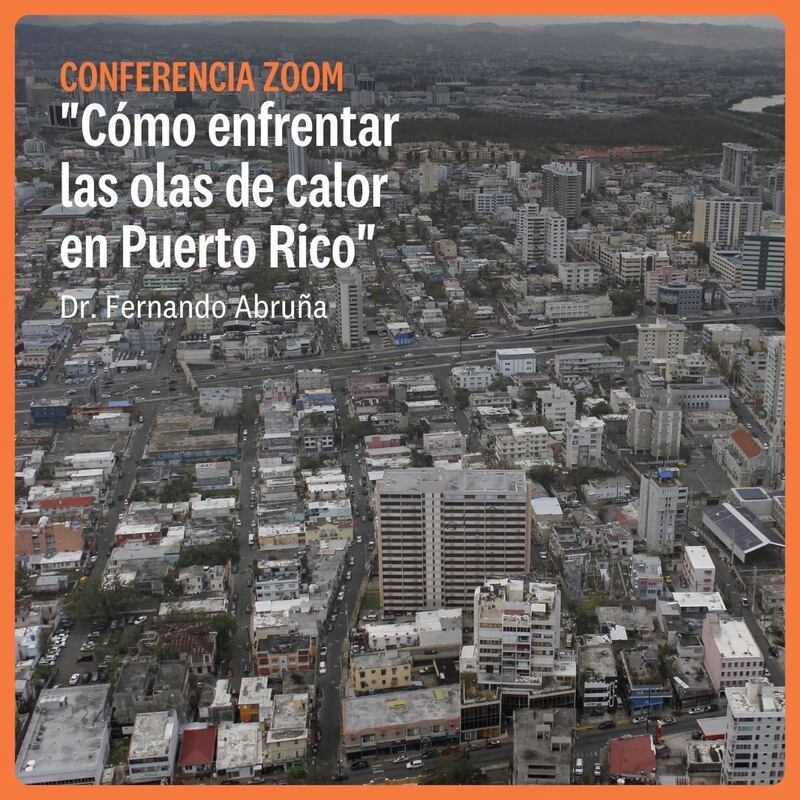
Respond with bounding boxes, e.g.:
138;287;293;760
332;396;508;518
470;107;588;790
0;0;800;800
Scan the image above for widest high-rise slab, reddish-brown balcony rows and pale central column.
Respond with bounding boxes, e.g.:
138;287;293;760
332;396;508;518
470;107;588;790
376;468;531;611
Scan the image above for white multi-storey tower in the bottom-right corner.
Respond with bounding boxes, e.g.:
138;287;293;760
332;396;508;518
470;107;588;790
721;678;786;786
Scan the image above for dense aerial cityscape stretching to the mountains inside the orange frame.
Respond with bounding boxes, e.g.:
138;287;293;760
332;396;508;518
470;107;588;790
14;17;786;785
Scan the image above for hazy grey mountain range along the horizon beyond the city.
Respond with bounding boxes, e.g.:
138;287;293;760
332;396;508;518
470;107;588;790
16;17;784;56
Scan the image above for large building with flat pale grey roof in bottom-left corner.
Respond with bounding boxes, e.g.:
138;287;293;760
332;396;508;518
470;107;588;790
16;683;111;785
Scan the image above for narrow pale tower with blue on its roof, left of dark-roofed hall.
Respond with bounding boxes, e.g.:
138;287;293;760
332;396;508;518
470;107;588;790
639;469;689;553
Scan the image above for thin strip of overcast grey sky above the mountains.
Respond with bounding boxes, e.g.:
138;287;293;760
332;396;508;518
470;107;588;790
24;14;783;29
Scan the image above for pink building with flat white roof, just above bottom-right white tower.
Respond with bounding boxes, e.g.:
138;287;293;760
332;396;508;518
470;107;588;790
703;614;764;692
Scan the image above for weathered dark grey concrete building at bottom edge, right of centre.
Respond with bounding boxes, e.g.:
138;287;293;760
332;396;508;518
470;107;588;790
513;708;575;785
